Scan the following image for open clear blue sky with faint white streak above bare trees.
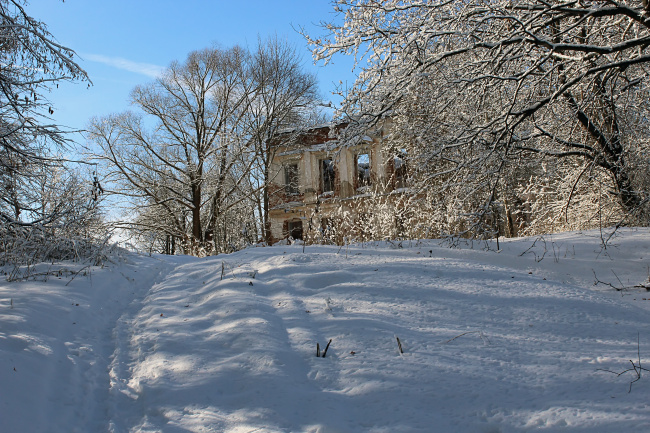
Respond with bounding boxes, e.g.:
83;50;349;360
26;0;354;137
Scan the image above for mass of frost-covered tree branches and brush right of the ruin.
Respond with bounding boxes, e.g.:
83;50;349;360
307;0;650;236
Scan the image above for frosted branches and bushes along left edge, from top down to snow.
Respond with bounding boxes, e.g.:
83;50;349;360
0;0;106;267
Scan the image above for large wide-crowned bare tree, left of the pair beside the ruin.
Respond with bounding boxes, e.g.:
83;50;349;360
91;47;255;254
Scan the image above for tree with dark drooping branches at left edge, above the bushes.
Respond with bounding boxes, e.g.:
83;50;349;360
0;0;88;224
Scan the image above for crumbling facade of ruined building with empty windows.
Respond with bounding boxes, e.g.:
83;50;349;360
268;125;406;244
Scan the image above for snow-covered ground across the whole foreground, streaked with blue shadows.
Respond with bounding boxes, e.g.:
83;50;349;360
0;229;650;433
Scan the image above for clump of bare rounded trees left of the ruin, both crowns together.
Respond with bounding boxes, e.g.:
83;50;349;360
90;38;317;256
